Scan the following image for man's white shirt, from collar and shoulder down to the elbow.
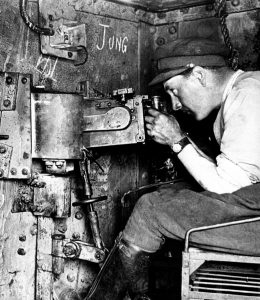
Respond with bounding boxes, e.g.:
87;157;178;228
214;70;260;189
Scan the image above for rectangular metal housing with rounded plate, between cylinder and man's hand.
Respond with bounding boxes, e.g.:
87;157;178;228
83;94;147;148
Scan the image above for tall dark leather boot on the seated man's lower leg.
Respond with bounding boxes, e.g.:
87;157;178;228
85;237;150;300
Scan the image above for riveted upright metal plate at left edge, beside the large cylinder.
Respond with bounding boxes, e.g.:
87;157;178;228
0;72;32;179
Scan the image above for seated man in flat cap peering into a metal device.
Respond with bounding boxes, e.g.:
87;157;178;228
87;41;260;300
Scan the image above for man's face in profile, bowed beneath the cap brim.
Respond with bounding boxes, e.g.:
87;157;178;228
164;70;211;121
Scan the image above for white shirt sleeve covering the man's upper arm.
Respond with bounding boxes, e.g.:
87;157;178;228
216;88;260;188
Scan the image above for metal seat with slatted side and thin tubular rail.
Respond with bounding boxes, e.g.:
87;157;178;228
181;217;260;300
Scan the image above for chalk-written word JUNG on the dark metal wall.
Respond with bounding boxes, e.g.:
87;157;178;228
96;24;128;53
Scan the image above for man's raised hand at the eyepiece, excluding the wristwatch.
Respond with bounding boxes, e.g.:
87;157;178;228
145;109;185;146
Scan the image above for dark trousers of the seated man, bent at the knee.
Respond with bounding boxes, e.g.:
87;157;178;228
123;180;260;255
